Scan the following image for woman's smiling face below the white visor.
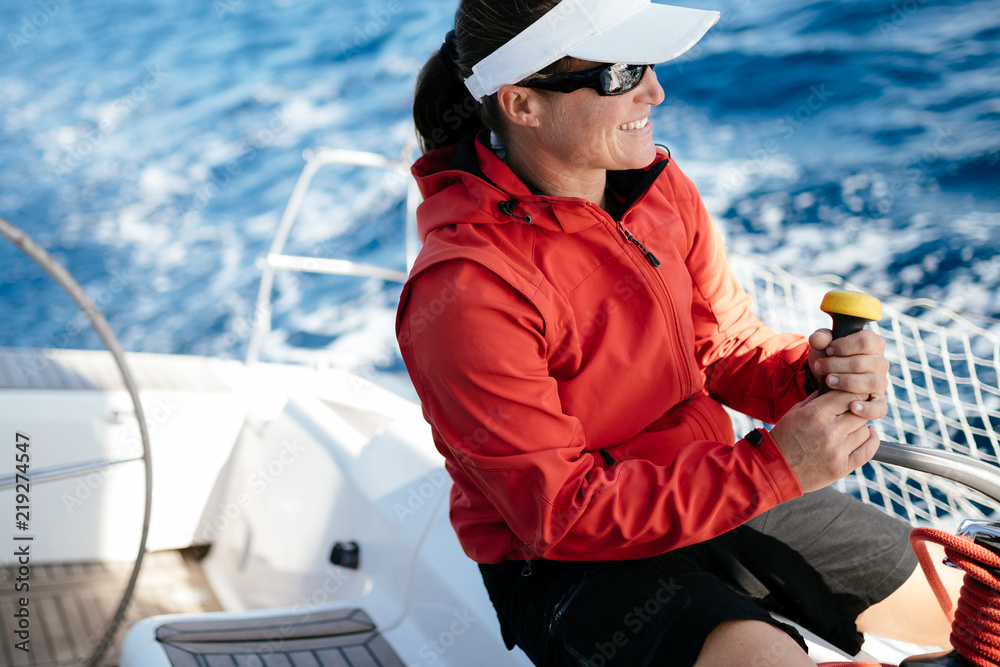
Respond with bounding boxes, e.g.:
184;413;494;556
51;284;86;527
539;63;664;171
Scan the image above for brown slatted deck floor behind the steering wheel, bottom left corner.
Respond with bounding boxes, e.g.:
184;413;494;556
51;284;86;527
0;549;221;667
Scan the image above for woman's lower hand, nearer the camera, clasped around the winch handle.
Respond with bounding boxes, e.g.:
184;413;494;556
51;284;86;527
771;391;887;493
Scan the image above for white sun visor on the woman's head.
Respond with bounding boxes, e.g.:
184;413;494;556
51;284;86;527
465;0;719;100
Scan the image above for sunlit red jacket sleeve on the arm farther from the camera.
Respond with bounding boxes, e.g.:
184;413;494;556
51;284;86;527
672;170;816;424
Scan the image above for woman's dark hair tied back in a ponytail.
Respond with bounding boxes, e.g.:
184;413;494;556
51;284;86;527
413;0;572;153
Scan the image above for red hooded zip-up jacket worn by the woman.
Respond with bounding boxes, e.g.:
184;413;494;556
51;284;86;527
397;133;809;563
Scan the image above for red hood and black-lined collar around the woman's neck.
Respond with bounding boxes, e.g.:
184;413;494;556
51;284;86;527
411;130;669;243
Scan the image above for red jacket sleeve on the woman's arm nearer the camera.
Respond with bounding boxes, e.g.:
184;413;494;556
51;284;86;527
398;260;801;560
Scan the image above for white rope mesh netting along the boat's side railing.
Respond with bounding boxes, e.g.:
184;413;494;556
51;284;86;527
730;255;1000;531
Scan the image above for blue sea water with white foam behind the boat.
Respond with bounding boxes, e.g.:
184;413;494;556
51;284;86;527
0;0;1000;378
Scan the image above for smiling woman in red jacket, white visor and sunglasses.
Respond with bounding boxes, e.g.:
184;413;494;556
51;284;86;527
397;0;954;666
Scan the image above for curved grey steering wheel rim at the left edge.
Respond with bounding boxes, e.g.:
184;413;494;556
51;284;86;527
0;217;153;667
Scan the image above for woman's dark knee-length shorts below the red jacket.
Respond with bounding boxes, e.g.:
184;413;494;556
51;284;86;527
480;489;917;667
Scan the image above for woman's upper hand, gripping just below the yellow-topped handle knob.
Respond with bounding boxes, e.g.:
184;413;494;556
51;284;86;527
809;329;889;419
